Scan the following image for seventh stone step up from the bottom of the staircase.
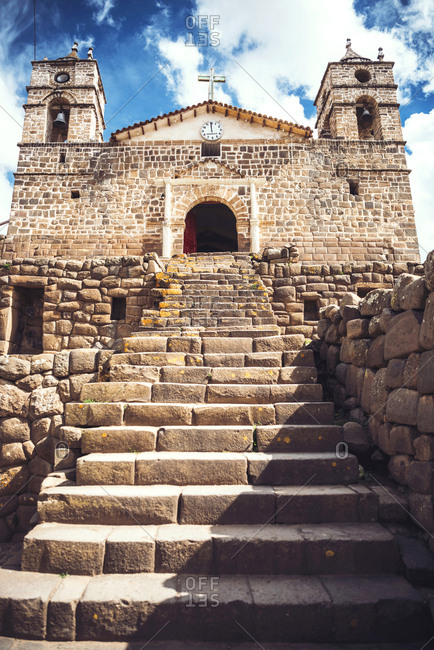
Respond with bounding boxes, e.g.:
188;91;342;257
81;382;322;404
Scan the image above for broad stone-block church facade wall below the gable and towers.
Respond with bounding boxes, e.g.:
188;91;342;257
0;140;418;263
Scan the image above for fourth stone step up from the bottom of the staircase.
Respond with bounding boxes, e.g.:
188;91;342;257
76;451;359;485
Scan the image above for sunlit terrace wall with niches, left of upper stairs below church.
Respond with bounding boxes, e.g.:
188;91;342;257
0;255;160;353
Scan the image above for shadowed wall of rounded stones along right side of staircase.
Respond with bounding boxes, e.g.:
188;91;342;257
318;251;434;531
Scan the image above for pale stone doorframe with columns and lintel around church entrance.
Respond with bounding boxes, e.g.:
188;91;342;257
162;177;266;258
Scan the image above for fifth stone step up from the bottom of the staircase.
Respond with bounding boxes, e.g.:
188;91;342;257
79;425;340;454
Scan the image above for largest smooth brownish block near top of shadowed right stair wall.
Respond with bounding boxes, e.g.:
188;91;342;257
384;310;422;361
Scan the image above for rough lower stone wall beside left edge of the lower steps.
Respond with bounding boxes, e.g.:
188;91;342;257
0;349;107;541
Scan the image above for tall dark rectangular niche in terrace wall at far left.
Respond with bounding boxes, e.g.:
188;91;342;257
9;287;44;354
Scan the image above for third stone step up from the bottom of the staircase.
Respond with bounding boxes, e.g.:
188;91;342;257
38;483;378;526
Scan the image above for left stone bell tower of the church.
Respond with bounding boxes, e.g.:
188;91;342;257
22;43;106;143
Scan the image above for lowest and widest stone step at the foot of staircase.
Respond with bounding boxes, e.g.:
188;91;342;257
0;567;432;636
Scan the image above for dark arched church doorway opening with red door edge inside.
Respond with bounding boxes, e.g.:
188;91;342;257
184;201;238;253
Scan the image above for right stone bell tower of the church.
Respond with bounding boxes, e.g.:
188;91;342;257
315;39;403;141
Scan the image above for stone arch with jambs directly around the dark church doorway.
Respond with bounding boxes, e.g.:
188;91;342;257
171;184;250;255
